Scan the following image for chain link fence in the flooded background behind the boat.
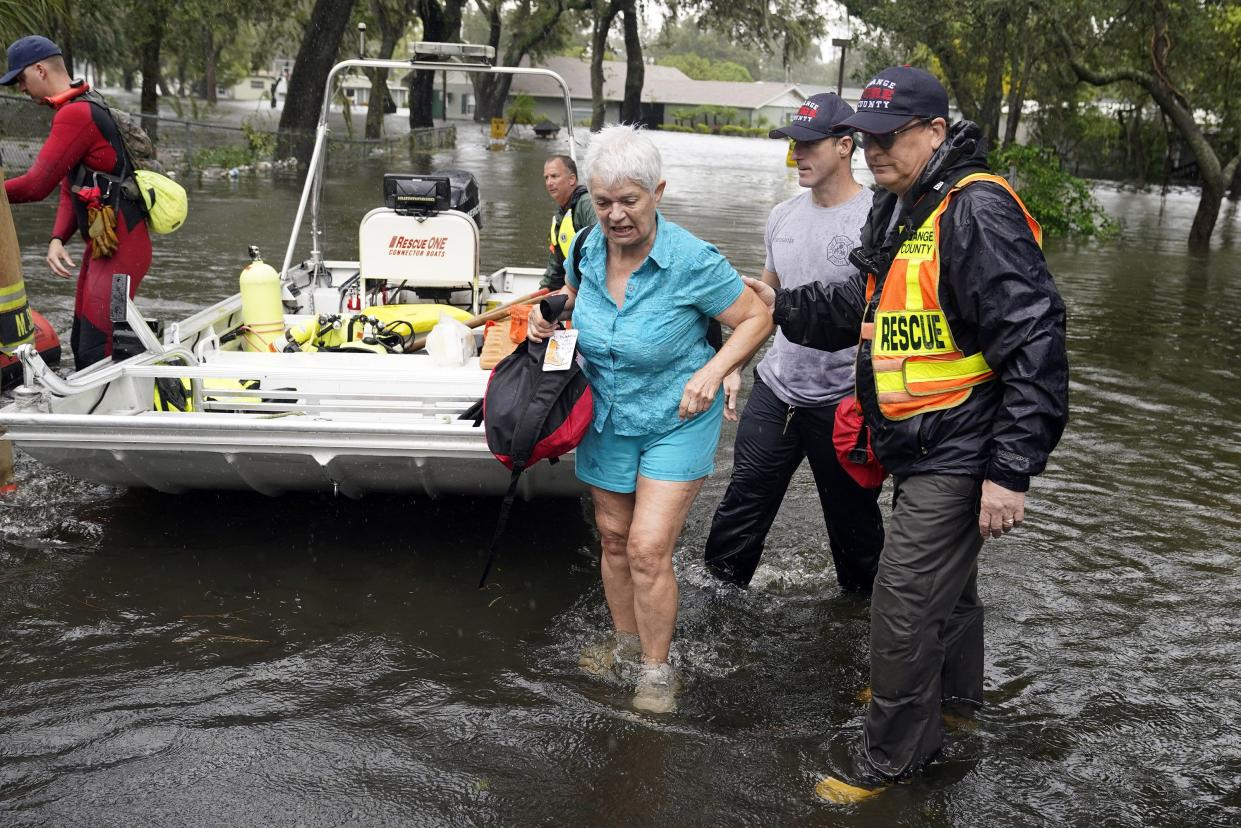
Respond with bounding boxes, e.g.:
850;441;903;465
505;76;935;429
0;94;457;178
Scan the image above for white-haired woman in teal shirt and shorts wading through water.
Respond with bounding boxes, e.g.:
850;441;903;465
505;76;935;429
529;127;772;713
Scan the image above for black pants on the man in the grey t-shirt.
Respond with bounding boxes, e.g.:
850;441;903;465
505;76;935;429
706;374;884;592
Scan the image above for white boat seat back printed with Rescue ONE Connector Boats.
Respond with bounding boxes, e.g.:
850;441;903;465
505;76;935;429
357;207;479;295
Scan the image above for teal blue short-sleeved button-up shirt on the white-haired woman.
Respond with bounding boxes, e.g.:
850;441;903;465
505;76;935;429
566;214;745;436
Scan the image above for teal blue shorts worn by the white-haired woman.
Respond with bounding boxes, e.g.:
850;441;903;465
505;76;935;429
573;391;724;494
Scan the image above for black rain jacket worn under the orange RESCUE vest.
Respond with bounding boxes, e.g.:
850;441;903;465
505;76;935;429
774;120;1069;492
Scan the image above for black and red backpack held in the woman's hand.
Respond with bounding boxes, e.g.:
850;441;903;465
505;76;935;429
478;294;594;588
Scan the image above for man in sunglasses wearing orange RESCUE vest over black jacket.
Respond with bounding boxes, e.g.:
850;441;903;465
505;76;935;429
746;67;1069;803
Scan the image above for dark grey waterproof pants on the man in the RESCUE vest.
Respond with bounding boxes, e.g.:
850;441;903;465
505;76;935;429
862;474;983;780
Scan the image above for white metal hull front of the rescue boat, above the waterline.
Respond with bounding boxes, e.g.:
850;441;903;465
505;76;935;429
4;412;583;499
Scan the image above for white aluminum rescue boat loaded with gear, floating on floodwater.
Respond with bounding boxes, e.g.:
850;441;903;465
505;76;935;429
0;43;585;499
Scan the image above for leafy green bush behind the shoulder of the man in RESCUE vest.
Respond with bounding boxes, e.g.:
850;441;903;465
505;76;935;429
988;144;1116;238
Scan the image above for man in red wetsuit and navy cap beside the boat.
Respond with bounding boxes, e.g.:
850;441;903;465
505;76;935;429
0;35;151;370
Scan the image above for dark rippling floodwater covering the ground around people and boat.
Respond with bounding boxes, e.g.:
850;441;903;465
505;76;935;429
0;128;1241;826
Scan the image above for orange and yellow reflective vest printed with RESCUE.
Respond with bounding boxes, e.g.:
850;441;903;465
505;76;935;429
861;173;1042;420
